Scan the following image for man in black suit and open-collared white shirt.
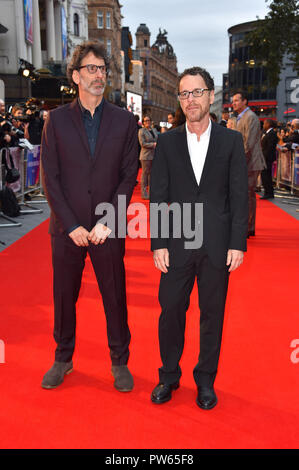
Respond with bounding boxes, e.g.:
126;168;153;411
150;67;248;409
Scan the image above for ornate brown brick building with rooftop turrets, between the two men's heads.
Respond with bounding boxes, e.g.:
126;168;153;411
136;23;178;124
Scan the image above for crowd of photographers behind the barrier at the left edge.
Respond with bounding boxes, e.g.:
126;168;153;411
0;98;48;148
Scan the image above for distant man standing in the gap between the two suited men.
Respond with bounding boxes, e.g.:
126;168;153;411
138;115;158;199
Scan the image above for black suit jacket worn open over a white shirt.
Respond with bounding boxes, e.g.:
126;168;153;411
150;122;248;268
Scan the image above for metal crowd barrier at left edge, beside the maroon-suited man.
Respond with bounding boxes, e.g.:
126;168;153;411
0;145;47;227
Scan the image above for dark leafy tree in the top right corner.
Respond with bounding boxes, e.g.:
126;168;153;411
248;0;299;87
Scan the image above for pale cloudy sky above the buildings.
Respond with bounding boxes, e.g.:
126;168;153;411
120;0;269;86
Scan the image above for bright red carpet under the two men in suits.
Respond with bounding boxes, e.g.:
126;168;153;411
0;188;299;449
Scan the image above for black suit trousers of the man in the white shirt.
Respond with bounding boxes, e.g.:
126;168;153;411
159;247;229;387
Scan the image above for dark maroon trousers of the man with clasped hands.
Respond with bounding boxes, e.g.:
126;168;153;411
51;235;131;365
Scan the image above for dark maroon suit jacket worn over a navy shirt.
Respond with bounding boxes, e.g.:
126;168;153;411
41;100;138;239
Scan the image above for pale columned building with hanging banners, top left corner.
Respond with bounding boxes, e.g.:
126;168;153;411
0;0;88;106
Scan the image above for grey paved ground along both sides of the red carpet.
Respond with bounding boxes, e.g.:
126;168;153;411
0;190;299;251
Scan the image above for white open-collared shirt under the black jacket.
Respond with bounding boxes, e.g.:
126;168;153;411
186;119;212;184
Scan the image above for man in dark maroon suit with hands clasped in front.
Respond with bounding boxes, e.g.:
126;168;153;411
41;41;138;391
